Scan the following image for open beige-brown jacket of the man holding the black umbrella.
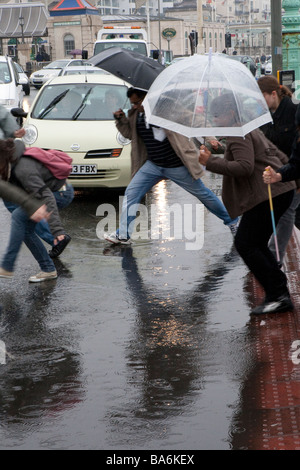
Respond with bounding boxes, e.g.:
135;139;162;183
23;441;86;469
116;109;203;179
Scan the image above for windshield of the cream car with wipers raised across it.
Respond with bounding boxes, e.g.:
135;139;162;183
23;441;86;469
31;83;130;121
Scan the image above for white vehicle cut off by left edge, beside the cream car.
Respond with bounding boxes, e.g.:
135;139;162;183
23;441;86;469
0;56;25;110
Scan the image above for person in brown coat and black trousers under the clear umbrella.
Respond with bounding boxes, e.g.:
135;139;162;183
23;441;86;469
199;93;295;314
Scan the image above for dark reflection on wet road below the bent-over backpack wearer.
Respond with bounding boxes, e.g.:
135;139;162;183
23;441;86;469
0;284;84;428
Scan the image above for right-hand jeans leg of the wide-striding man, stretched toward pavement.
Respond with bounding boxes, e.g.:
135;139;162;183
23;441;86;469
164;166;238;225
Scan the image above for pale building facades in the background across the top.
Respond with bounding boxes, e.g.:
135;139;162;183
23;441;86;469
0;0;271;66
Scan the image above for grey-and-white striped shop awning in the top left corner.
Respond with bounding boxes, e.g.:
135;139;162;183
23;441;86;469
0;3;49;38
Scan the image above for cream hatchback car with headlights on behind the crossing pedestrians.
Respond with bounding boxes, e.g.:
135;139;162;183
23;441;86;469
17;73;131;188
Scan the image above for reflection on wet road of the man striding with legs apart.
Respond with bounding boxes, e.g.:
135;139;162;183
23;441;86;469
104;246;239;428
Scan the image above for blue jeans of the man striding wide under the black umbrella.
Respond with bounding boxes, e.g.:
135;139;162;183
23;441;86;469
117;160;238;238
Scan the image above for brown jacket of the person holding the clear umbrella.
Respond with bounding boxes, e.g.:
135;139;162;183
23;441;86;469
206;129;296;219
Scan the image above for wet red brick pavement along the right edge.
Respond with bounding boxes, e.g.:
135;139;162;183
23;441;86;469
239;228;300;450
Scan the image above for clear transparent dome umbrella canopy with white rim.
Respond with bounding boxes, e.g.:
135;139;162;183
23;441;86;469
143;53;272;137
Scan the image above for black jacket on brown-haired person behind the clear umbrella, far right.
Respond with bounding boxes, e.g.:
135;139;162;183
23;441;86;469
261;96;297;157
